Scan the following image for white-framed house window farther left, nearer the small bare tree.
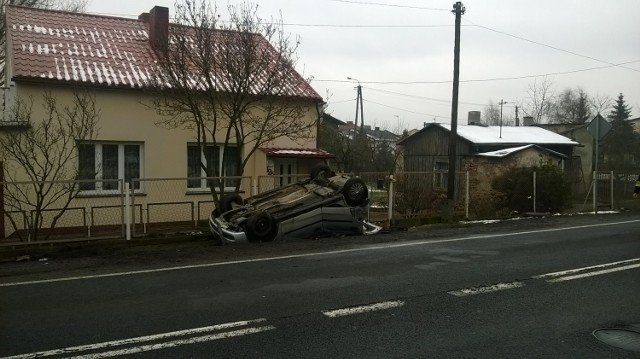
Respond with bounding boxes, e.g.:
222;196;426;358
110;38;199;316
78;142;142;191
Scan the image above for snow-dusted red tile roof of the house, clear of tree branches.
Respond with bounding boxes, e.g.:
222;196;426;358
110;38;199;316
6;6;321;101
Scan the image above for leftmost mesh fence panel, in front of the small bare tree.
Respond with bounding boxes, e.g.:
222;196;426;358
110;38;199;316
0;181;124;242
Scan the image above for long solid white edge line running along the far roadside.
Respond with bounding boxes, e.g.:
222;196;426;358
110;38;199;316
0;219;640;287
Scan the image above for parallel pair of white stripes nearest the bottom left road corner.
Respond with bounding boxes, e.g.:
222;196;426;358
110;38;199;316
0;318;275;359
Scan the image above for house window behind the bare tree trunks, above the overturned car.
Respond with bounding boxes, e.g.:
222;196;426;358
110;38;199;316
187;144;240;190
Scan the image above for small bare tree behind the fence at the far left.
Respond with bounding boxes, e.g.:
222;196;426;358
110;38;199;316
0;91;99;240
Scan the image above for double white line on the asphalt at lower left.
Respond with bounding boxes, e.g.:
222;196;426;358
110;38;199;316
0;318;276;359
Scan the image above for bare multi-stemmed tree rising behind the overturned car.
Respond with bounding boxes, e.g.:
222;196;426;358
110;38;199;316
153;1;319;202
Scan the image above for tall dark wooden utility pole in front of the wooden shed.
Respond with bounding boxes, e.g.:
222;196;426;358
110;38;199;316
446;1;465;222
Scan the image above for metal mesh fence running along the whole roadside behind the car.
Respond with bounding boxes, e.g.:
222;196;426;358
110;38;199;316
0;172;637;242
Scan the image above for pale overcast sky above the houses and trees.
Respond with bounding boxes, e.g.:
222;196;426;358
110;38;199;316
87;0;640;133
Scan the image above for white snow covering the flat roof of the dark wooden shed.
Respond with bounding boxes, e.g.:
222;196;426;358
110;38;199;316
430;123;579;146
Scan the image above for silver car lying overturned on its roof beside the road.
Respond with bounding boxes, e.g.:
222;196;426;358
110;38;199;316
209;165;381;243
